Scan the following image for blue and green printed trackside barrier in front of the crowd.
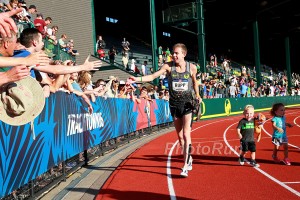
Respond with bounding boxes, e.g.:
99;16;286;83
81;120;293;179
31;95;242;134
0;92;300;198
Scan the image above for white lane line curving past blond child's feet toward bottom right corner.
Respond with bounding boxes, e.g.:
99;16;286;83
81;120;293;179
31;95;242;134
223;122;300;197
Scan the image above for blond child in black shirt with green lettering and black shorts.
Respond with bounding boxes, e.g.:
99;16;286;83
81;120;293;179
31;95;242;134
237;105;260;167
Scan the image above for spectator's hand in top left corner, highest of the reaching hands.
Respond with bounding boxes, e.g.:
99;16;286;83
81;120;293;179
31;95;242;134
0;8;23;37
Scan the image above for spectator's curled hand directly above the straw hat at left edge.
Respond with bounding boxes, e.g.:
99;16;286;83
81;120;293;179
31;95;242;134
0;65;30;85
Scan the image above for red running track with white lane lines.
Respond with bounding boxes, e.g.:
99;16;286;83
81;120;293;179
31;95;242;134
96;108;300;200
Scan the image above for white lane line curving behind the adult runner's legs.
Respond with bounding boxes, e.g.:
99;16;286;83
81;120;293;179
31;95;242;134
167;119;232;200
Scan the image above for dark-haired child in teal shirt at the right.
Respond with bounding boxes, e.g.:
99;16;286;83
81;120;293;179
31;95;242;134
270;103;292;165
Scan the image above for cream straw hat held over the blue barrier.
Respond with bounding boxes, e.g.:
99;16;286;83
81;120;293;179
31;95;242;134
0;77;45;126
